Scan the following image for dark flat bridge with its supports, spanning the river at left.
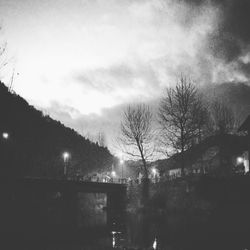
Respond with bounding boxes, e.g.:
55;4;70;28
0;178;127;231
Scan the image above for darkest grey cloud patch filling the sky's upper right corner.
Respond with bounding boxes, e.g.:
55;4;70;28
180;0;250;62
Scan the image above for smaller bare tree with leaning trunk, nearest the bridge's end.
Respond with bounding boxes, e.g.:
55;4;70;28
119;104;154;179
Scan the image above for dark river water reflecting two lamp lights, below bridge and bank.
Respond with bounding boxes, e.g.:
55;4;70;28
33;209;250;250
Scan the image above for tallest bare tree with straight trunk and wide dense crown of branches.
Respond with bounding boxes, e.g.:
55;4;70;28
159;76;206;171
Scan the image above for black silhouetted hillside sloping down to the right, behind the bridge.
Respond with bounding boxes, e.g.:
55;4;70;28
0;82;113;177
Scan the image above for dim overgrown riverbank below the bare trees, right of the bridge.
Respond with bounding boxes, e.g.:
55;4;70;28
127;178;215;215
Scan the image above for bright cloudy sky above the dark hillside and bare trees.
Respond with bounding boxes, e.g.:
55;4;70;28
0;0;250;154
